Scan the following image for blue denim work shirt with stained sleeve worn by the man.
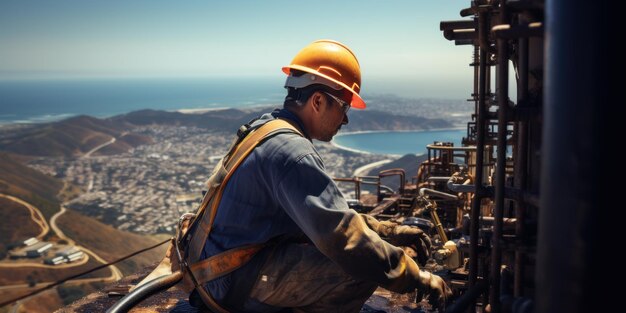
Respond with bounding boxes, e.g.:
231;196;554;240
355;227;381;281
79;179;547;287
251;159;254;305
201;109;419;308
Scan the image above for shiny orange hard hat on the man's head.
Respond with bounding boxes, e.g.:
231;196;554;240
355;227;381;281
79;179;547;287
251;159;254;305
283;39;365;109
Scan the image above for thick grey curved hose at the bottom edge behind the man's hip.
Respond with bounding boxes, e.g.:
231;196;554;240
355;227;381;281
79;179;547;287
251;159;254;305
106;271;183;313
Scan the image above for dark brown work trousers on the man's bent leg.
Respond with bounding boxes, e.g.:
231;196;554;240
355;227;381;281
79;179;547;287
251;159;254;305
244;243;377;313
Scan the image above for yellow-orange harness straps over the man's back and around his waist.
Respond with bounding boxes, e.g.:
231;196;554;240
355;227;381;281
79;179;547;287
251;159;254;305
185;119;302;313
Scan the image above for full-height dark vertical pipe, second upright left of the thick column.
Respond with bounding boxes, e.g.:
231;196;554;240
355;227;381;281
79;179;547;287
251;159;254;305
489;1;509;313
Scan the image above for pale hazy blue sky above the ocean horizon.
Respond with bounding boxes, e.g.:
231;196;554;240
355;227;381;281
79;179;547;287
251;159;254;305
0;0;473;97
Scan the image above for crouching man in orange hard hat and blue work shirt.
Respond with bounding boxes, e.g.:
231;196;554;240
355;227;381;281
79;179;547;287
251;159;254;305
190;40;451;312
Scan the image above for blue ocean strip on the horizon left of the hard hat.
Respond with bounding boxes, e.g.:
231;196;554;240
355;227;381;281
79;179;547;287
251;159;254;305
0;76;285;124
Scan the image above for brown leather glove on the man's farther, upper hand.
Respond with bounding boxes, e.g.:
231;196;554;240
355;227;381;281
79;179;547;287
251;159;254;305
360;214;432;265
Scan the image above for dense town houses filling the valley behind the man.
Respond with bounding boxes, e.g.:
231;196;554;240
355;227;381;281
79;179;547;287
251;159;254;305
30;125;387;234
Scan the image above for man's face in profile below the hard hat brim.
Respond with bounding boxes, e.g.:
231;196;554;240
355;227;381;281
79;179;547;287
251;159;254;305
316;92;350;142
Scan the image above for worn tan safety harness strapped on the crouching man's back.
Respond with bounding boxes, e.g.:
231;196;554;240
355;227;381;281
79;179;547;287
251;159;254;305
174;119;303;313
